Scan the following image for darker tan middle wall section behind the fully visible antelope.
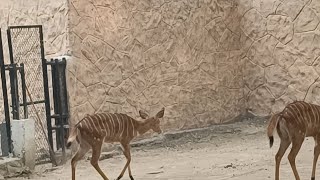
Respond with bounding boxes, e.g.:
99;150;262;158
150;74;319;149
68;0;246;130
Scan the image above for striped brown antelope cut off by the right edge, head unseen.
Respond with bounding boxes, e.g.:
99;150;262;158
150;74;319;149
267;101;320;180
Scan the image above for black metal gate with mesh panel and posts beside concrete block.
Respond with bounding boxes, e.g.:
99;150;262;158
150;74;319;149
0;25;68;163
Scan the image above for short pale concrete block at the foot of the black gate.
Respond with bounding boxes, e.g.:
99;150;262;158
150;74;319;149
11;119;36;170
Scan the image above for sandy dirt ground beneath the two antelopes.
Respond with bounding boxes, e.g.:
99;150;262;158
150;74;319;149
12;119;320;180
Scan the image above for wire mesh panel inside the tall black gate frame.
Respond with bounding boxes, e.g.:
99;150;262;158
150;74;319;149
8;27;50;163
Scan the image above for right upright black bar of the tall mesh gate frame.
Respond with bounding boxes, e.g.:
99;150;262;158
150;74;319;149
39;26;53;150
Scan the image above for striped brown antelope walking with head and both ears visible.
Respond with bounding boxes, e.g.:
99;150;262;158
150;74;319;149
67;108;164;180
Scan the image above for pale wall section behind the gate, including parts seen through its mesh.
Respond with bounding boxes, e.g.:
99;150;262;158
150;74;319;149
0;0;69;158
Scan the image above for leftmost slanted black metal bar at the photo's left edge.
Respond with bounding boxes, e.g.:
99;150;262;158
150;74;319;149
0;29;12;153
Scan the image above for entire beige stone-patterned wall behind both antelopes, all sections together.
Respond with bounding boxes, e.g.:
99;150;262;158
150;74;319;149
0;0;320;130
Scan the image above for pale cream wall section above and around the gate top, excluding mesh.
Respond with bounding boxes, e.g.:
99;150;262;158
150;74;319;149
0;0;69;119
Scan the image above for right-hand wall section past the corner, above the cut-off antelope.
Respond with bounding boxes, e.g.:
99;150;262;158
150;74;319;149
240;0;320;115
